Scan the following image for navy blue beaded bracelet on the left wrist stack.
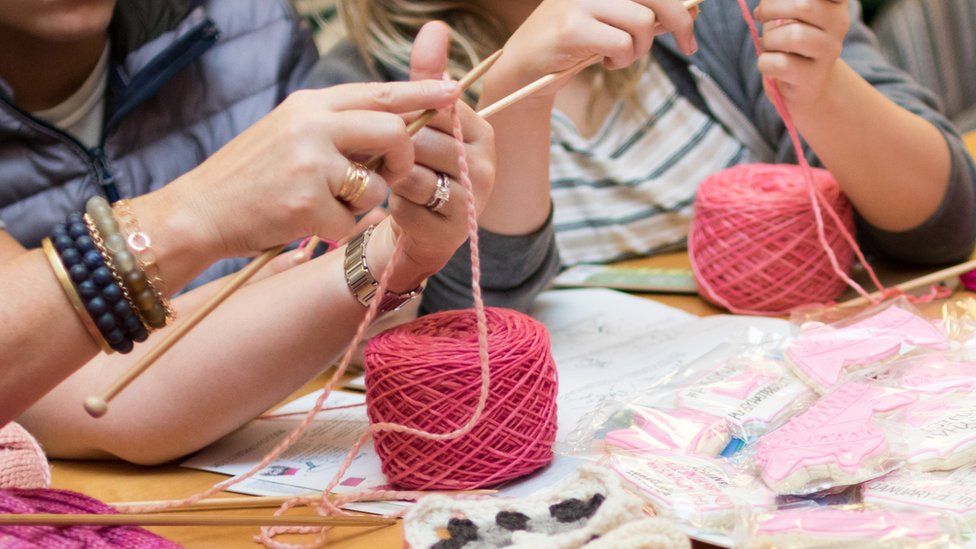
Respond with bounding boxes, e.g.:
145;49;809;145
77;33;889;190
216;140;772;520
51;212;149;354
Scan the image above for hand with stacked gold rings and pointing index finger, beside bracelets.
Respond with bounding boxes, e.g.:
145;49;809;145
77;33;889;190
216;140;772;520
160;80;460;261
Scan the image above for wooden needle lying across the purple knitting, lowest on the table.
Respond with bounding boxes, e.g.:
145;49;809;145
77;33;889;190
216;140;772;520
0;514;397;526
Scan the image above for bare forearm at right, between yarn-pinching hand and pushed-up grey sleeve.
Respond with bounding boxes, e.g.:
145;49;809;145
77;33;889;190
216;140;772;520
792;61;951;231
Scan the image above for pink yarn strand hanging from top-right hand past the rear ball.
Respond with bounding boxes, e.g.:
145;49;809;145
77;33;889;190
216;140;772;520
723;0;887;304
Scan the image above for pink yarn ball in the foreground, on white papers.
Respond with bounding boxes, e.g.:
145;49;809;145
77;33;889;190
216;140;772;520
365;308;557;490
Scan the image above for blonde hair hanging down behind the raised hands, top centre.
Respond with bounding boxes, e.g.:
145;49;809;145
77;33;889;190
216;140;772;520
338;0;647;110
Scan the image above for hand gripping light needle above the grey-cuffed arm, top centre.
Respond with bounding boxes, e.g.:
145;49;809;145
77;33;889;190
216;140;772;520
486;0;698;100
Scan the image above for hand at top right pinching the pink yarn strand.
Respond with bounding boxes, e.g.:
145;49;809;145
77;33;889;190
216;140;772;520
755;0;851;108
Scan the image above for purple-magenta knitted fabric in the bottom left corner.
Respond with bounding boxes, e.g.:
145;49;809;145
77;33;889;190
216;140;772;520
0;490;179;549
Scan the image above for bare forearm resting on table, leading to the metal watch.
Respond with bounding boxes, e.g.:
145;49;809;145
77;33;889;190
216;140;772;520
21;244;365;463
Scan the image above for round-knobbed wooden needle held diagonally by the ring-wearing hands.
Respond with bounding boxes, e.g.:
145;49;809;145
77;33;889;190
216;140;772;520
85;50;504;418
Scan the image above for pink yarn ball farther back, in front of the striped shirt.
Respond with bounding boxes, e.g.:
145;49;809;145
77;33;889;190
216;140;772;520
688;164;854;315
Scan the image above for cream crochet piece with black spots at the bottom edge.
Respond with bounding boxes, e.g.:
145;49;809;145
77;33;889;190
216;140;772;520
404;465;690;549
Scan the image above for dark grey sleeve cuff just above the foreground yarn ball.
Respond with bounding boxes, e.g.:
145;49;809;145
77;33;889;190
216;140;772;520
420;210;559;314
